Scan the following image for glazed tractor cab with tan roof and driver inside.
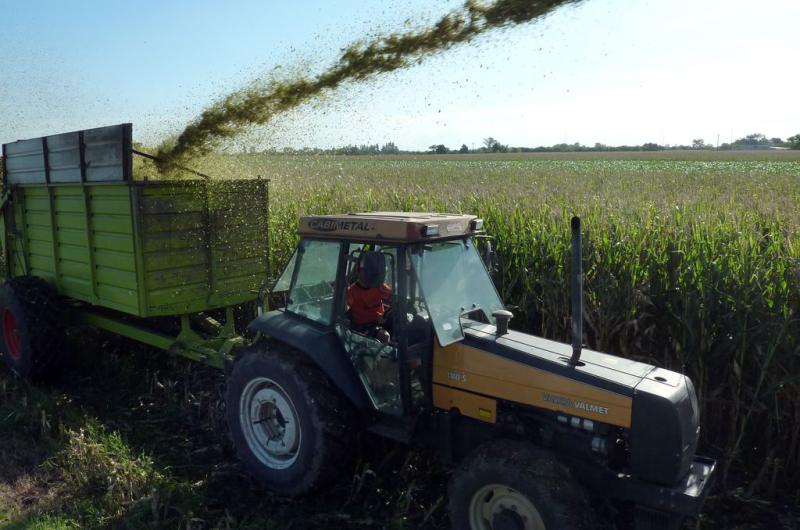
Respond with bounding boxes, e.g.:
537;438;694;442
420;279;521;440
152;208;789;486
273;212;494;416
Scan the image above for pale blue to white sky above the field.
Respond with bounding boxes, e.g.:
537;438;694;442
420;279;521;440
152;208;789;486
0;0;800;149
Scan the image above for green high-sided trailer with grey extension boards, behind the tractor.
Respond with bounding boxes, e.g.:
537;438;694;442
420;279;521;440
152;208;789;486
0;124;269;375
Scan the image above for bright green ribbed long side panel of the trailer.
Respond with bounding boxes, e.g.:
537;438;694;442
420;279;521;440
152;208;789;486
12;183;139;315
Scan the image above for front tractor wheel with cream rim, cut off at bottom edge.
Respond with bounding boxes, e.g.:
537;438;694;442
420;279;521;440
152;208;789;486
448;440;591;530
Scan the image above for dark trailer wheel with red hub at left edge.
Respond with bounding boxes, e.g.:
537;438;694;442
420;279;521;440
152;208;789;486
0;276;64;379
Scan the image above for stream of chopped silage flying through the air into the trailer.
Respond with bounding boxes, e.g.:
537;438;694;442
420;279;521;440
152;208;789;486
157;0;581;172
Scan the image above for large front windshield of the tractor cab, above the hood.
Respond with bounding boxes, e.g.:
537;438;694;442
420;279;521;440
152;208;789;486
411;240;503;346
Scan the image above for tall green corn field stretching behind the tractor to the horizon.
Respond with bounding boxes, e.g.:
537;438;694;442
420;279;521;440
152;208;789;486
203;155;800;496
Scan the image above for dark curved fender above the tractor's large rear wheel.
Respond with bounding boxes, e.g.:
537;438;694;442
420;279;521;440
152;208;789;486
247;310;371;409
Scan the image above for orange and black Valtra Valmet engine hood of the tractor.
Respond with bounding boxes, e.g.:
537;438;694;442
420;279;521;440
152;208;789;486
446;324;700;485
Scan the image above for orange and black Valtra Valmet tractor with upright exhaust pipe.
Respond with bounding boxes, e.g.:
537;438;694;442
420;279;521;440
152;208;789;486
226;212;715;530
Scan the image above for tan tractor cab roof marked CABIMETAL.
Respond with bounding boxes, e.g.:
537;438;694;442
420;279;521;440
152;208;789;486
298;212;483;243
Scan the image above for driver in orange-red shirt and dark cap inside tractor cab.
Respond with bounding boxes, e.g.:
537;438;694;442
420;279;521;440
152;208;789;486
347;252;392;342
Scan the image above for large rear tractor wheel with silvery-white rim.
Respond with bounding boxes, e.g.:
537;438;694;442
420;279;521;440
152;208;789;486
225;343;353;496
